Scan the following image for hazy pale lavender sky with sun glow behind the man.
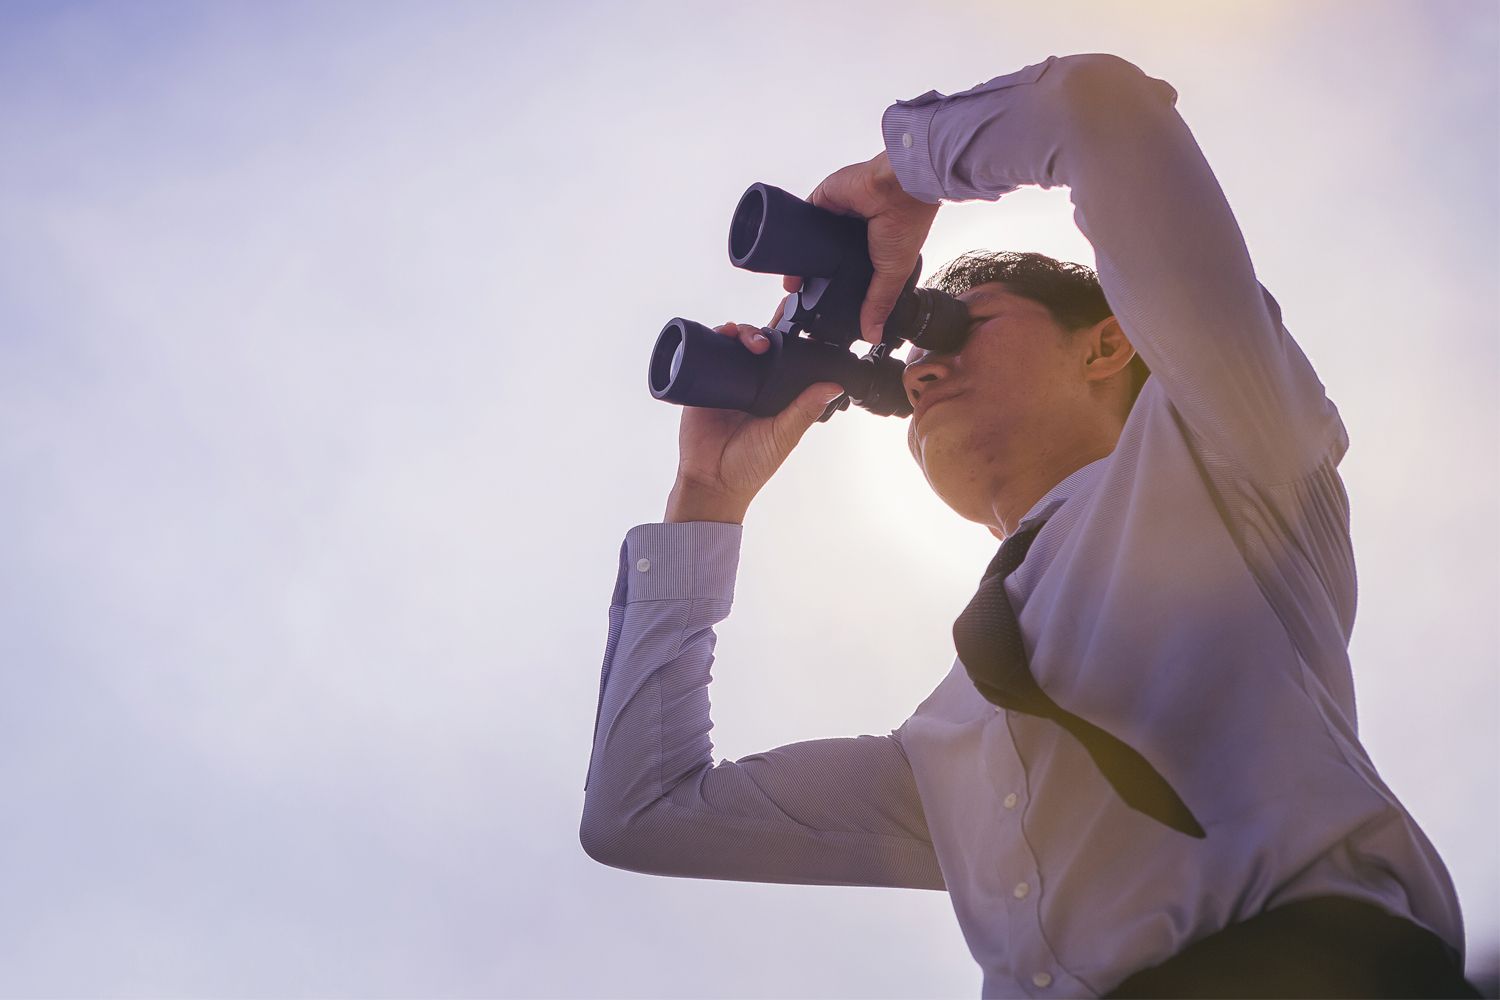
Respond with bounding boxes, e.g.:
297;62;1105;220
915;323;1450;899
0;0;1500;997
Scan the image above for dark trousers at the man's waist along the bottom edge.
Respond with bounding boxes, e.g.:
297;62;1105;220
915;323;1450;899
1106;897;1479;999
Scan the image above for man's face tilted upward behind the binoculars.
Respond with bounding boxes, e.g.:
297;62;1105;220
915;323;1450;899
903;283;1091;523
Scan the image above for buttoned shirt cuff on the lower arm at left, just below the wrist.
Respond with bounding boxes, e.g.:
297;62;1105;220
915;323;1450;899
614;520;744;604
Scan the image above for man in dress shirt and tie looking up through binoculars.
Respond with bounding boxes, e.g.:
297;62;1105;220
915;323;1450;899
581;55;1476;997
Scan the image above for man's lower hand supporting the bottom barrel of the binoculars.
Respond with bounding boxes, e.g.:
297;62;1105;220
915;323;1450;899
666;309;843;525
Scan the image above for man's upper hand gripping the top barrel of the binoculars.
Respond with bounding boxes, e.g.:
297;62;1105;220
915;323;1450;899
782;150;938;343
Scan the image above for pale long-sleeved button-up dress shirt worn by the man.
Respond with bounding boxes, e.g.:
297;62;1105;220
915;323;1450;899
581;55;1463;997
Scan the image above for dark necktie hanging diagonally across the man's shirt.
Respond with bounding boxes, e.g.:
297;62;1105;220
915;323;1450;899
953;523;1203;838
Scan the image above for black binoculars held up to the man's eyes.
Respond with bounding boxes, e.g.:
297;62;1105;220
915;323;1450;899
648;184;969;421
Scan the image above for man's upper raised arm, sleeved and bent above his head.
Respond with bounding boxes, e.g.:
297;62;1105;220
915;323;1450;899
815;54;1347;484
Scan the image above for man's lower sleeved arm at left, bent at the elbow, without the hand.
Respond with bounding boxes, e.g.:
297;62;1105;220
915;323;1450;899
579;522;944;889
